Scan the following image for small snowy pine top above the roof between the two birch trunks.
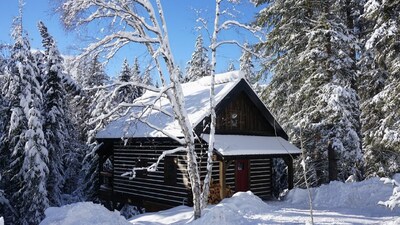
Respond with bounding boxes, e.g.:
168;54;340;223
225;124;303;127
184;35;211;82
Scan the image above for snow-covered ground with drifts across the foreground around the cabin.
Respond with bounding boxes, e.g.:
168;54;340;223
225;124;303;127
41;176;400;225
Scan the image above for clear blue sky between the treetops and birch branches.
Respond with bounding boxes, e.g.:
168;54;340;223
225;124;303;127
0;0;260;76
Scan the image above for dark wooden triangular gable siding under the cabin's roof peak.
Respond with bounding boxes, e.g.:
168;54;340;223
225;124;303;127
216;91;274;136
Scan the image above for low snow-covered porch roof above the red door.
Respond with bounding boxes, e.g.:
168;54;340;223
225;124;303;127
201;134;301;156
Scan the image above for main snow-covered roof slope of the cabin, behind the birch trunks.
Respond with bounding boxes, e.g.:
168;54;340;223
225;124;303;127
96;71;243;138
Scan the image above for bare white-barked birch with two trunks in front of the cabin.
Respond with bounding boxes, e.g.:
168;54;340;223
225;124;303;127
60;0;255;219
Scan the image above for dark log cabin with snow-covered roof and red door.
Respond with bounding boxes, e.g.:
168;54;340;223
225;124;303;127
96;71;300;211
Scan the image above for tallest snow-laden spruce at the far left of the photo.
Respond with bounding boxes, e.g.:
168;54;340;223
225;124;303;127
5;6;49;224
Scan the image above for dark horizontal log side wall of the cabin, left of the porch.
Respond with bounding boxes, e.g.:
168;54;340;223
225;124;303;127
113;139;219;206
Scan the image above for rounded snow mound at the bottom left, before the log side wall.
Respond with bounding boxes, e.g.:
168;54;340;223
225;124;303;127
40;202;131;225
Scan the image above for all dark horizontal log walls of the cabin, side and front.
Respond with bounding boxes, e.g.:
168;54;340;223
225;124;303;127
103;139;272;206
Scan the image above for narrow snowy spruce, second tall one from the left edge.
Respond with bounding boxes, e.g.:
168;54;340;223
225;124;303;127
38;22;77;206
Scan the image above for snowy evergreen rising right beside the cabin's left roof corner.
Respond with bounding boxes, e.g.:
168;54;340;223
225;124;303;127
69;56;109;201
